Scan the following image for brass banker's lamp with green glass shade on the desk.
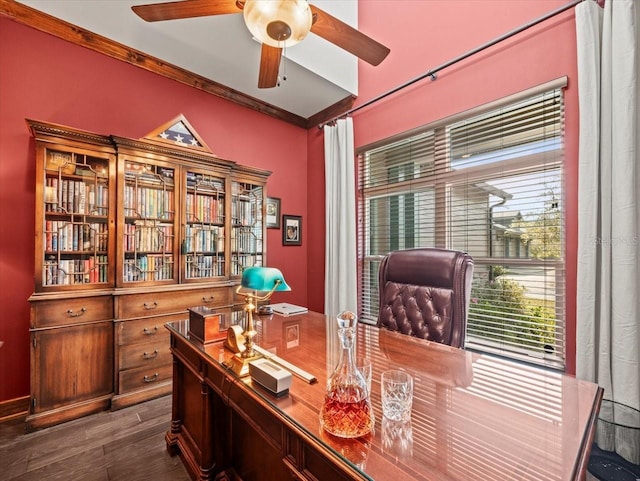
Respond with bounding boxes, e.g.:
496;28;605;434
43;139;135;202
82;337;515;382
227;267;291;376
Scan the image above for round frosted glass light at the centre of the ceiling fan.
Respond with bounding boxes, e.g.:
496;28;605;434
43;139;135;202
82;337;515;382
243;0;312;48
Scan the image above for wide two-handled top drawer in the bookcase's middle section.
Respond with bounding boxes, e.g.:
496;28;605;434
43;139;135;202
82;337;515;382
118;287;229;319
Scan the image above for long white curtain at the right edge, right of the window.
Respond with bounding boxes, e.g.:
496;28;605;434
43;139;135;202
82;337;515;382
576;0;640;464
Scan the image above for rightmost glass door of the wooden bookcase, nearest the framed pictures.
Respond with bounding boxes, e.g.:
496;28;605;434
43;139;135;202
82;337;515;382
231;181;264;276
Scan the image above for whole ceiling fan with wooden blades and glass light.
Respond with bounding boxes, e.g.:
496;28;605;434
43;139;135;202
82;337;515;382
131;0;389;88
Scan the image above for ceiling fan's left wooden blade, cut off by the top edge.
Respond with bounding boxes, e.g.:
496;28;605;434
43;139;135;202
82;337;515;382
131;0;244;22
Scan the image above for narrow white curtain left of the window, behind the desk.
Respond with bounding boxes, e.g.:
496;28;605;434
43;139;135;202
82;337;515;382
324;117;358;316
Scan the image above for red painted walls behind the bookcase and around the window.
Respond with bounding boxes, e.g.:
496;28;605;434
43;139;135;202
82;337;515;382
0;0;578;402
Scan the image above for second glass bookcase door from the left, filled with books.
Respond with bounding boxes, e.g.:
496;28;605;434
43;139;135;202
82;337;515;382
121;161;177;283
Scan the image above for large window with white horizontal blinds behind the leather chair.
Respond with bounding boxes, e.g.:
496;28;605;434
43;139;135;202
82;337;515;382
358;81;565;369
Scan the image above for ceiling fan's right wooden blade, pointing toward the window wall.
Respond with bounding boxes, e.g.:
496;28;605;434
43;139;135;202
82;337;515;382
309;5;390;65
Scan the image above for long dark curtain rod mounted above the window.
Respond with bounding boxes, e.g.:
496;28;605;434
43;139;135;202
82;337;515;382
318;0;584;129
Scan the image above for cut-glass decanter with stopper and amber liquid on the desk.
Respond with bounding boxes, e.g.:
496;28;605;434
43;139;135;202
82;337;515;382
320;312;374;438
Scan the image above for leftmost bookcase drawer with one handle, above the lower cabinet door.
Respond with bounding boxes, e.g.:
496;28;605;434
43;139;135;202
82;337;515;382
31;296;113;329
